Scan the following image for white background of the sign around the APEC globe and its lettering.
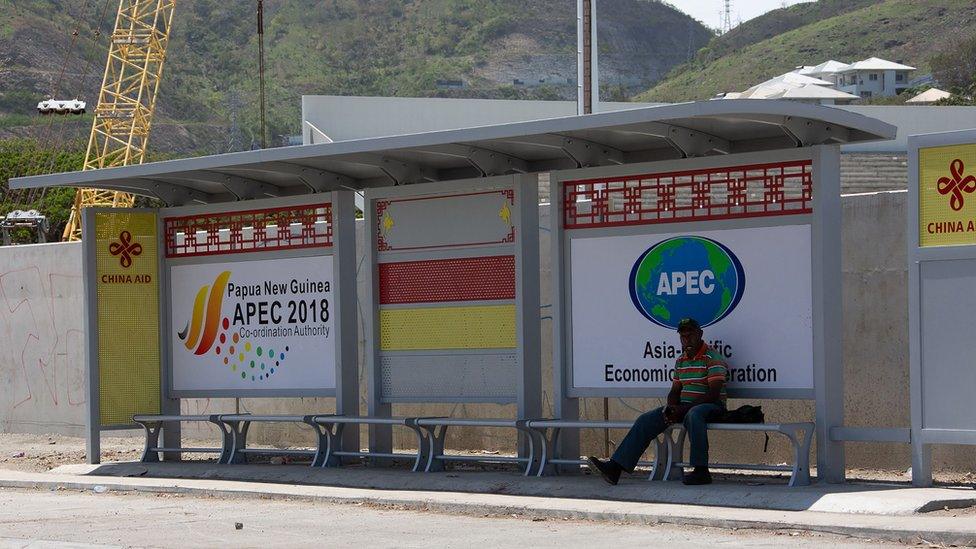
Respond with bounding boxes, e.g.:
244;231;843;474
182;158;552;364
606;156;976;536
571;225;813;389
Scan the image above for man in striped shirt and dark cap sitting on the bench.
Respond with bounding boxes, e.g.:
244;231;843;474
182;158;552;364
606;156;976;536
588;318;728;484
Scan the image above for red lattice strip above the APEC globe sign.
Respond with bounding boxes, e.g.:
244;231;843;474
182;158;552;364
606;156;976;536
563;160;813;229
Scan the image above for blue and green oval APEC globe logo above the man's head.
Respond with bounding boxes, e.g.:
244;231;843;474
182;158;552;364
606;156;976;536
629;236;746;330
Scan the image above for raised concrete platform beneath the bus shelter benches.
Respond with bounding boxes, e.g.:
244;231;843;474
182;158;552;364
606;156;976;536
52;462;976;515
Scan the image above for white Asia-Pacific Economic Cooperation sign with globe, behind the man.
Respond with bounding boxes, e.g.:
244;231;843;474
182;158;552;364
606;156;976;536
571;225;813;389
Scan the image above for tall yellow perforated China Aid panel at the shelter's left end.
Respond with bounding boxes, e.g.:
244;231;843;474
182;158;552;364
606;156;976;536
95;212;160;427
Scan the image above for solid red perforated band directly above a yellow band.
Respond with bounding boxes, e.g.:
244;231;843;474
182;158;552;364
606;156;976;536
379;255;515;305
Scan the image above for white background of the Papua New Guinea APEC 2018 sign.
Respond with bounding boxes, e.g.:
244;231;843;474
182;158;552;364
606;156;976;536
170;256;337;391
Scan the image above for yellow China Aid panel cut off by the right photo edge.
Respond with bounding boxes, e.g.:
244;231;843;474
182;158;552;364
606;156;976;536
918;144;976;248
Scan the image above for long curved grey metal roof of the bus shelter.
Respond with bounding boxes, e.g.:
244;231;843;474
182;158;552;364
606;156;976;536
10;100;896;206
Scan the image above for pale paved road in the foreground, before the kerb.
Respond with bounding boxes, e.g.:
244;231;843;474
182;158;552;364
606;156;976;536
0;489;893;549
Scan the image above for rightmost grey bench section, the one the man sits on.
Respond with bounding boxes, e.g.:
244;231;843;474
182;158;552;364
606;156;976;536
664;422;814;486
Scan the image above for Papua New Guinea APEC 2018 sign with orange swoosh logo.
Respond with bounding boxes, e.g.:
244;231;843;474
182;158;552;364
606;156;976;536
170;256;336;391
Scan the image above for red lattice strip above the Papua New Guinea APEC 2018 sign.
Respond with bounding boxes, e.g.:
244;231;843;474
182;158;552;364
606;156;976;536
163;203;332;257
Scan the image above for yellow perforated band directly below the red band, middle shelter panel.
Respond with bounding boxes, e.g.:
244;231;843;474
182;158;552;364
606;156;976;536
380;305;517;351
